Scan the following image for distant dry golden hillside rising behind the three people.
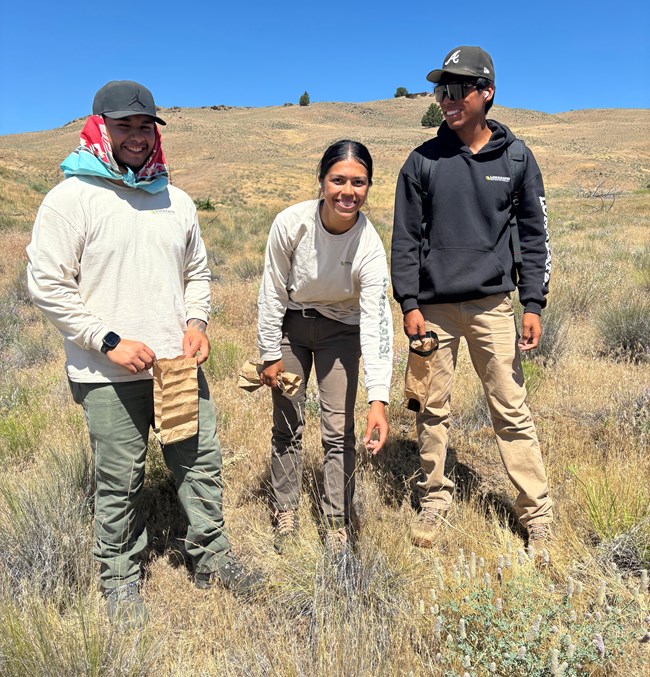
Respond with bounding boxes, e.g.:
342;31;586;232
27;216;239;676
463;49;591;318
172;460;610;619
0;97;650;218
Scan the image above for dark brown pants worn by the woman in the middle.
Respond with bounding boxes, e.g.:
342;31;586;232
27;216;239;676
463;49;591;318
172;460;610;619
271;310;361;522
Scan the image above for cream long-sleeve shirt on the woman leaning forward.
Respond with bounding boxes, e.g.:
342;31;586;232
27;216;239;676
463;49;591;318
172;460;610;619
257;200;393;402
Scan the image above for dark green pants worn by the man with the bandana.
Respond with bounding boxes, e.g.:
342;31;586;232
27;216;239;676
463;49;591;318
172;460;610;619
70;370;230;589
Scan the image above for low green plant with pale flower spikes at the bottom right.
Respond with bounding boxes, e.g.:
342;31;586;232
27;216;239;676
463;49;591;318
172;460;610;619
413;551;632;677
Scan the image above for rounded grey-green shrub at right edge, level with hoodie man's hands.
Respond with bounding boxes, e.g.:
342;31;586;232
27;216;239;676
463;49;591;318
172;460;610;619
597;298;650;363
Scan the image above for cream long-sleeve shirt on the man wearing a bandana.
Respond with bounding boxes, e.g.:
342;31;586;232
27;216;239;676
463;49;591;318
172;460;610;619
27;177;210;383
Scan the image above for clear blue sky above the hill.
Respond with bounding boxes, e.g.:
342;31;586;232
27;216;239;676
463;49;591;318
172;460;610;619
0;0;650;134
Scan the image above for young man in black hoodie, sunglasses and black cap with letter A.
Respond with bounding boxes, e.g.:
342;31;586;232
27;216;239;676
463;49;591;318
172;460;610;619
391;46;553;552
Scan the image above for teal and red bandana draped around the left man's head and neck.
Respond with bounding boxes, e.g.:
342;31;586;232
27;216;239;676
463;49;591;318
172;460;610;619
61;115;169;193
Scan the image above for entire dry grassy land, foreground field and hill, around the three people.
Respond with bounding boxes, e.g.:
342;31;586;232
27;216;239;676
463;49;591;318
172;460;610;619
0;97;650;677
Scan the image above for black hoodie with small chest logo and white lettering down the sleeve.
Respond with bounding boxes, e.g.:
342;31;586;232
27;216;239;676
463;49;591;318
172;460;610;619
391;120;551;314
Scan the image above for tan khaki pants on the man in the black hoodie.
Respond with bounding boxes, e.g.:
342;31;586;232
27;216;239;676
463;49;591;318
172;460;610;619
416;294;553;527
